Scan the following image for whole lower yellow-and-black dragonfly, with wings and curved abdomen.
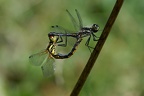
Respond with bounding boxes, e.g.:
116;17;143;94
29;31;78;77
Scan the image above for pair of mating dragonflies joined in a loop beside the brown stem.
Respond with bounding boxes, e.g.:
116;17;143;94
29;10;99;77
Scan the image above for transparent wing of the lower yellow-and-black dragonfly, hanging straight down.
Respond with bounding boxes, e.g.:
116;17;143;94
41;57;55;77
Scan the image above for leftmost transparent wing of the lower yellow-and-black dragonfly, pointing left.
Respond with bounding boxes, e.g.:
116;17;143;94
29;50;47;66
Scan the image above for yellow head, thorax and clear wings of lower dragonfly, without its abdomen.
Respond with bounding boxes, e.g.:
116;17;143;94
29;37;57;77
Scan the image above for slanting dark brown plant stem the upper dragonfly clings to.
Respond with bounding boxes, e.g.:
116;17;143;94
70;0;124;96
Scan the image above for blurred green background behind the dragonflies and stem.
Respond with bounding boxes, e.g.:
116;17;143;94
0;0;144;96
